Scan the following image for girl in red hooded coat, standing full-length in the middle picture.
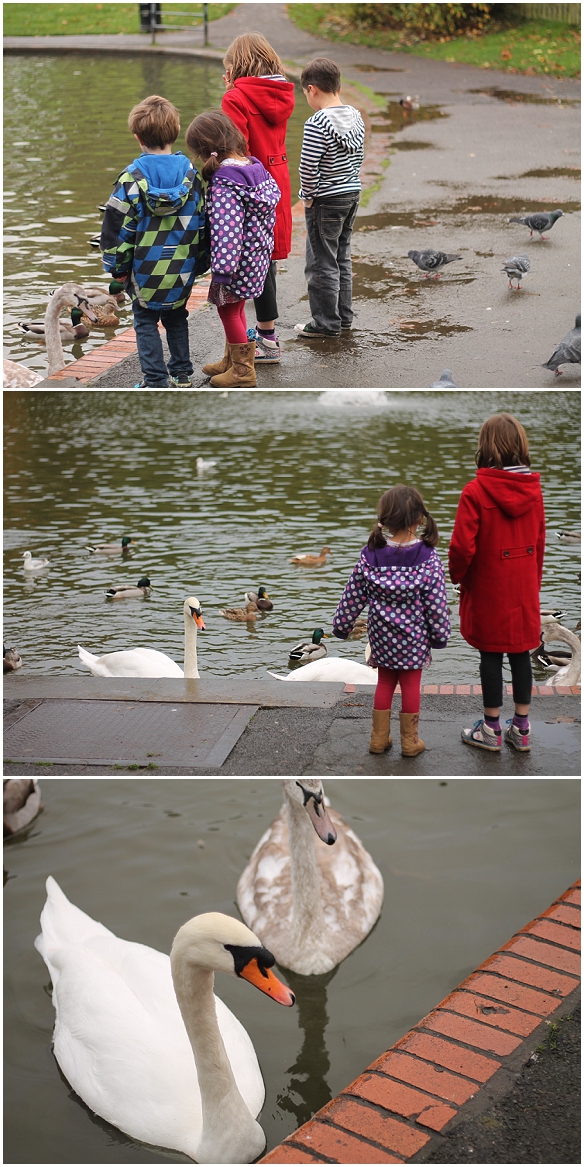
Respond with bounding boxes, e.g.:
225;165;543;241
449;413;545;753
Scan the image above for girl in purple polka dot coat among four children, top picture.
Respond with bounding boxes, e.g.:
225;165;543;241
186;110;280;389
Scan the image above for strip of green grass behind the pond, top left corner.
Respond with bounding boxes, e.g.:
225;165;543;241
4;4;235;36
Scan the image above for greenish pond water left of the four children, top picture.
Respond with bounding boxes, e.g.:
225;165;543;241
4;53;311;372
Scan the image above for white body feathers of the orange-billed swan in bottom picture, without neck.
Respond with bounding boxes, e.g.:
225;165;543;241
35;878;264;1158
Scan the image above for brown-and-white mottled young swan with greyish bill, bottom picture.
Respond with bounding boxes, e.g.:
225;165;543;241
237;778;383;977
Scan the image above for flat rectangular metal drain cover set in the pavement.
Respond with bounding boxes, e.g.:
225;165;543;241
4;700;258;769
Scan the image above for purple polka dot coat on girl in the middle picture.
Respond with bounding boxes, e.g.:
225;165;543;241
333;550;451;669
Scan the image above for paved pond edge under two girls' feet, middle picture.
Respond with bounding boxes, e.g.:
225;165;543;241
5;677;580;777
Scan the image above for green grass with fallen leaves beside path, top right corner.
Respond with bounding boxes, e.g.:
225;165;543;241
287;4;580;77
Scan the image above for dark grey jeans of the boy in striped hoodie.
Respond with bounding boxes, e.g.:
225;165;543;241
305;193;359;333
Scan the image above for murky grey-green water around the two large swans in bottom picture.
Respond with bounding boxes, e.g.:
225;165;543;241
5;777;579;1163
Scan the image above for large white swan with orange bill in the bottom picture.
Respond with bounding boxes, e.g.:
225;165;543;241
35;875;294;1163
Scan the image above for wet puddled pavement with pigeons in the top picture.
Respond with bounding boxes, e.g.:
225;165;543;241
14;5;580;389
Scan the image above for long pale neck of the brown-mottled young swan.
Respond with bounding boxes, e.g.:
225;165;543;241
286;794;325;949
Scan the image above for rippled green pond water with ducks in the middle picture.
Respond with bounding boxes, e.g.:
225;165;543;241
5;390;580;683
